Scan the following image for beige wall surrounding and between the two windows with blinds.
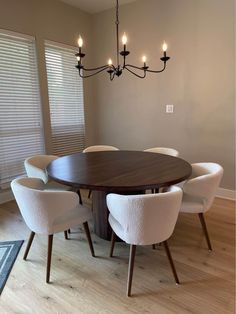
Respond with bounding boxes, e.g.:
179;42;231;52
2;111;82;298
0;0;96;153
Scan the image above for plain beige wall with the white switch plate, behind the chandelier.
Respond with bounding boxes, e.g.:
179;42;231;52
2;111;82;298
93;0;235;189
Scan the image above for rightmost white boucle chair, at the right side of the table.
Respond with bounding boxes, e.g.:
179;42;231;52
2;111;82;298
180;162;223;251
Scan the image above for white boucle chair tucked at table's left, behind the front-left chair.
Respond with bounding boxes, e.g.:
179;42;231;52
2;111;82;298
24;155;82;204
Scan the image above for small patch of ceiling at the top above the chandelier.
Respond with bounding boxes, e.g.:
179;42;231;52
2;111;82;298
61;0;136;14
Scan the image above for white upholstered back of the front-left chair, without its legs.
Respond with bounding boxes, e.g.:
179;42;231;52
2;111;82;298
11;178;82;234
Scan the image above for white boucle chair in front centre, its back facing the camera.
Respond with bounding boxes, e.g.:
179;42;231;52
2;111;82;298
107;187;182;296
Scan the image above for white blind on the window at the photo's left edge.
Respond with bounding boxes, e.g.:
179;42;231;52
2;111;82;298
0;30;44;189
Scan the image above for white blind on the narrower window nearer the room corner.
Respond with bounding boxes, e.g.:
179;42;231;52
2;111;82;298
45;42;85;155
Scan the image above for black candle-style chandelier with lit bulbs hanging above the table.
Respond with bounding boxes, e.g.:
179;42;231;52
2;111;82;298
75;0;170;81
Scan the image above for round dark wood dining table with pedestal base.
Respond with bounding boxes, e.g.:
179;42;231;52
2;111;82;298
47;150;192;240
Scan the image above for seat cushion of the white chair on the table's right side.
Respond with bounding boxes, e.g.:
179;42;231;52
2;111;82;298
180;194;204;214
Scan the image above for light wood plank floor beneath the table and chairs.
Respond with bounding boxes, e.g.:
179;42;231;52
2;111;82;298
0;193;235;314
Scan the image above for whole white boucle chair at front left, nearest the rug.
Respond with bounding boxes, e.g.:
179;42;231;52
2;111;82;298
11;178;94;283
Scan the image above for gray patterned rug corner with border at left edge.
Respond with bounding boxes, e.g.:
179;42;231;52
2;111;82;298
0;240;24;294
